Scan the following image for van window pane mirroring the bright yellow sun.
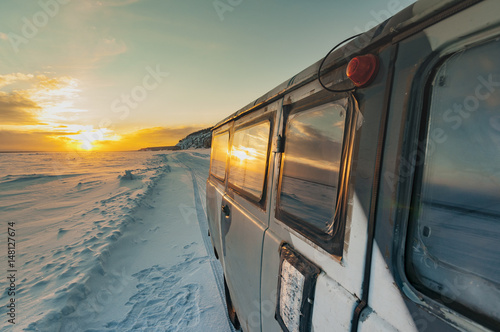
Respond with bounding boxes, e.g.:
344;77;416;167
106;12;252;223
229;120;271;199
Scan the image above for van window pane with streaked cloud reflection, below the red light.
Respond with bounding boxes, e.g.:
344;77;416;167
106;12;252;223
278;103;346;234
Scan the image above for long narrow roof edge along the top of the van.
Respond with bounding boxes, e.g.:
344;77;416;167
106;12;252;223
213;0;482;129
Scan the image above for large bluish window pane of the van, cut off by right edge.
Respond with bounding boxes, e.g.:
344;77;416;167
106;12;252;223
406;41;500;327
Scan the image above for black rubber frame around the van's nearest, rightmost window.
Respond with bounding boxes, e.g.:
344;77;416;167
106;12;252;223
392;33;499;328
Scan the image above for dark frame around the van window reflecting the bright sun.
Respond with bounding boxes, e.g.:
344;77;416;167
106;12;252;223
226;112;275;211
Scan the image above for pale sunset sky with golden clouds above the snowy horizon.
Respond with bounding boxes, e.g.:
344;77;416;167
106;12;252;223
0;0;413;151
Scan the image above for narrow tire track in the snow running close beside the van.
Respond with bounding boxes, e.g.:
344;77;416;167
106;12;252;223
175;152;236;332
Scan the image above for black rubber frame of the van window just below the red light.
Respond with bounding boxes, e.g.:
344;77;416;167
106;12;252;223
275;90;359;258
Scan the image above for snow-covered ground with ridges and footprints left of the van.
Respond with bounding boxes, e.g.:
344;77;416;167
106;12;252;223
0;150;231;331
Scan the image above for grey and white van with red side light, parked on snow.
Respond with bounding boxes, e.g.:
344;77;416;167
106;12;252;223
207;0;500;332
